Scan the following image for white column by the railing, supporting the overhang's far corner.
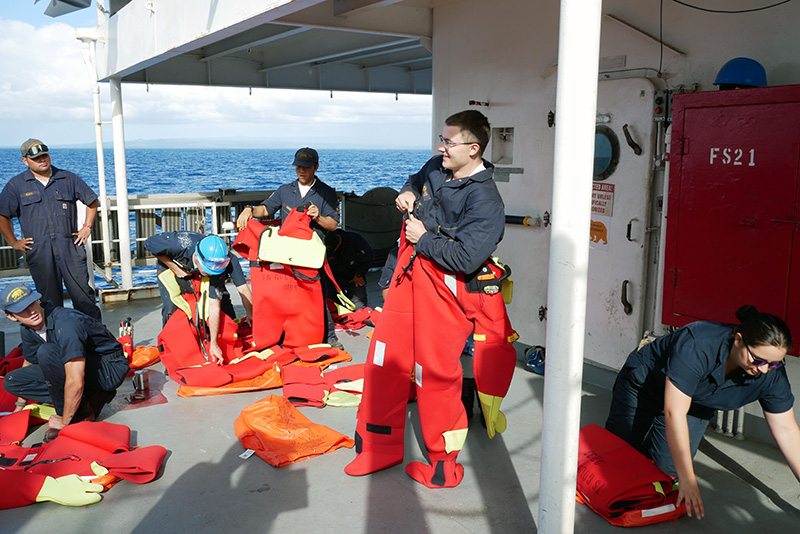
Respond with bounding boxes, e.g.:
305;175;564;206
108;78;134;289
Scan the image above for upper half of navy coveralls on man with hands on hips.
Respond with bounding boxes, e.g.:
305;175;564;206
0;166;97;237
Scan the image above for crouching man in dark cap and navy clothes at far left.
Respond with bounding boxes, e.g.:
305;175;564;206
0;283;130;441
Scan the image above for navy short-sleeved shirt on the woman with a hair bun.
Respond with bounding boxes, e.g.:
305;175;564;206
625;321;794;417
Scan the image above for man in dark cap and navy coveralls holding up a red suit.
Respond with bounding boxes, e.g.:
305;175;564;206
236;147;339;346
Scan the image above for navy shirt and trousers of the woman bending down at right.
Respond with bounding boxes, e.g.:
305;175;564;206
606;321;794;477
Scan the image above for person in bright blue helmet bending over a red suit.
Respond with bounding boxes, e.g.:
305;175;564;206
144;231;253;362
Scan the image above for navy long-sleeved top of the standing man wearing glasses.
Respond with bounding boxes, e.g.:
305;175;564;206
400;155;506;274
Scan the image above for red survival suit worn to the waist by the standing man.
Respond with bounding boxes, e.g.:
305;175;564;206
345;235;517;488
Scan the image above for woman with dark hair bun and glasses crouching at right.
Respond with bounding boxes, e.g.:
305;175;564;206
606;305;800;519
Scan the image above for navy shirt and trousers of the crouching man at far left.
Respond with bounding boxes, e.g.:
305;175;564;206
3;302;130;415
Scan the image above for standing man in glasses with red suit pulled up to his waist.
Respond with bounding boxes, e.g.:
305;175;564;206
345;110;517;488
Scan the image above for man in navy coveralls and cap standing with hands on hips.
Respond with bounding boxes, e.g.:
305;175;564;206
0;139;101;320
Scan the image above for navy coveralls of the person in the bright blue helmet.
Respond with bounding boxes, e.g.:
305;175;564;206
144;230;247;325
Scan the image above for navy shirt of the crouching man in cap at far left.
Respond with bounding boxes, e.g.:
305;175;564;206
20;302;122;370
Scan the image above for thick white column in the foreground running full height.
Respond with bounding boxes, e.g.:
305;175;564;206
538;0;602;534
